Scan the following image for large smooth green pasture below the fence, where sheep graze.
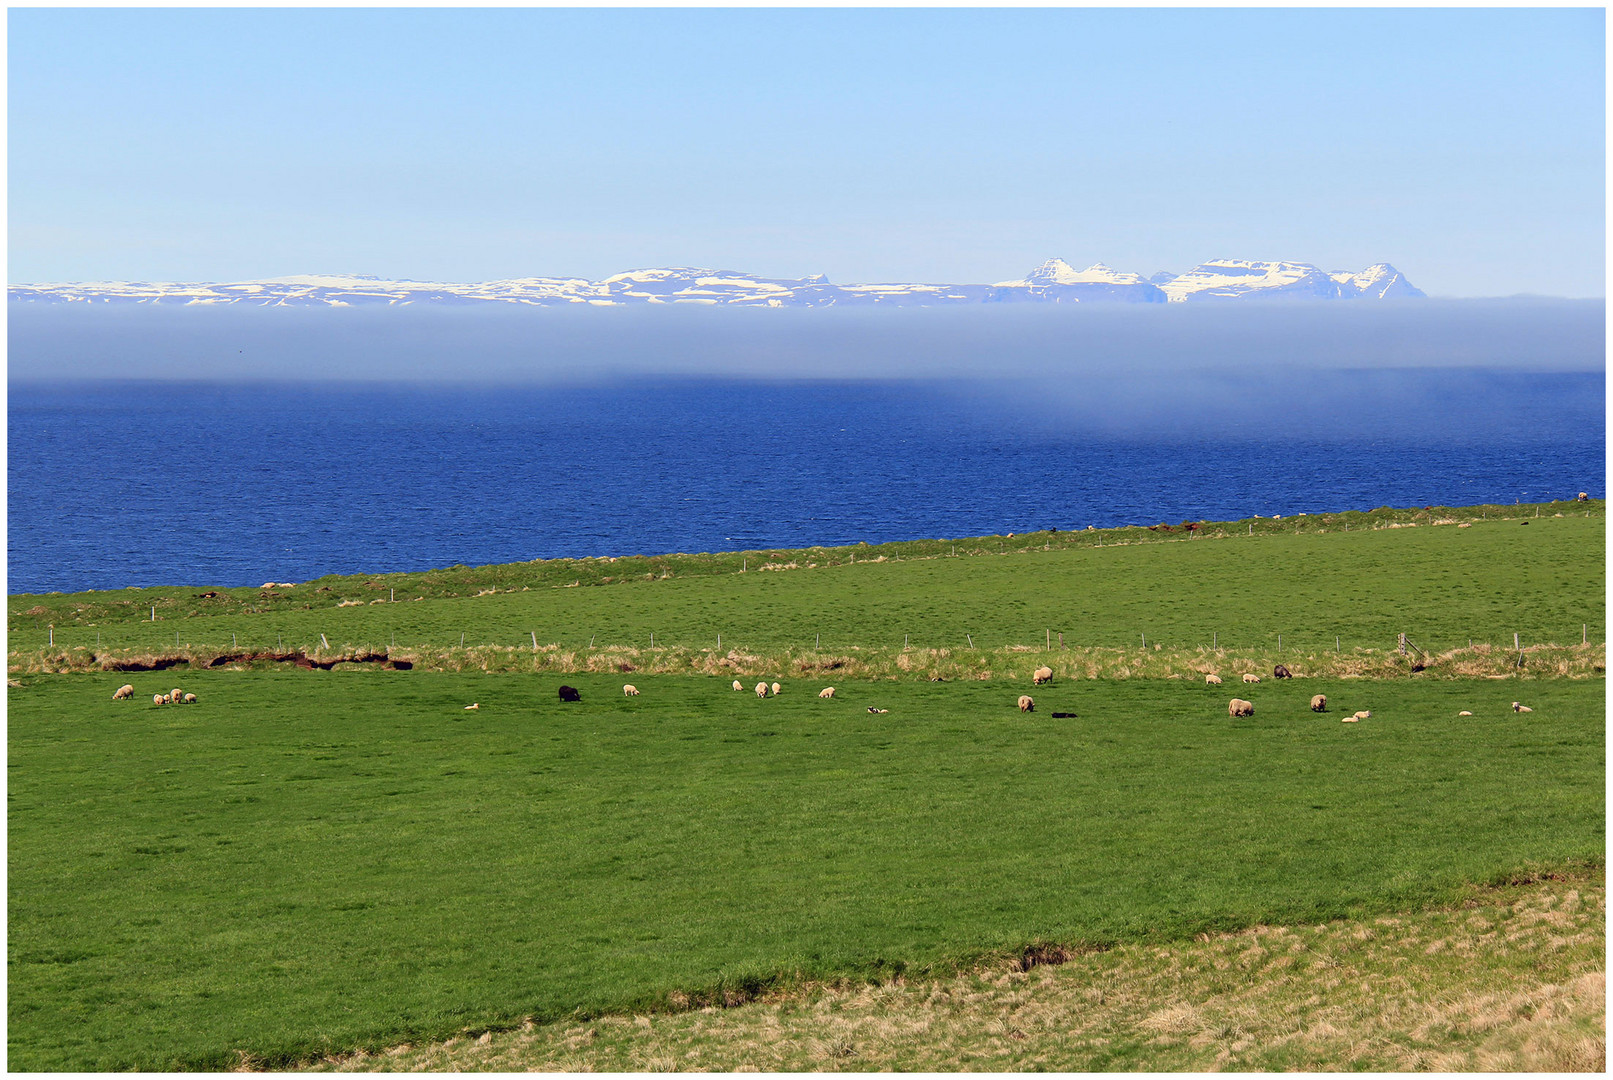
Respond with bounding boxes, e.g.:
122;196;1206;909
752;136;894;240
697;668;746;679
8;671;1605;1070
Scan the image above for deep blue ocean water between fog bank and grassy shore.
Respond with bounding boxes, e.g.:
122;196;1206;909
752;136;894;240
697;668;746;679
6;371;1607;593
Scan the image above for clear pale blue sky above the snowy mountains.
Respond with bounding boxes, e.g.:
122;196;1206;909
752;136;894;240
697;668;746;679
8;8;1605;297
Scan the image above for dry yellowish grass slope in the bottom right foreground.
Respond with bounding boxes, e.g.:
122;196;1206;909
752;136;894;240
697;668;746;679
315;867;1607;1072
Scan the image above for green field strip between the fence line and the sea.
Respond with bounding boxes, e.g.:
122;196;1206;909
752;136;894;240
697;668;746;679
10;514;1607;654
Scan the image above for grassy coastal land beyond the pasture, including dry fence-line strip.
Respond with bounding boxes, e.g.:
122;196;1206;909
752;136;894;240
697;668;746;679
8;500;1607;679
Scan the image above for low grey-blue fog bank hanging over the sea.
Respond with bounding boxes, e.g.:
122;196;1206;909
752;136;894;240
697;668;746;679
10;298;1605;387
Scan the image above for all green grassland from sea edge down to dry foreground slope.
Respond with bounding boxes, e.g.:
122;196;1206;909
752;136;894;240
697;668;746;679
6;503;1605;1070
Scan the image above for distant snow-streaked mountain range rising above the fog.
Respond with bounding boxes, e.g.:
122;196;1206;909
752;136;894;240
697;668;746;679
10;260;1423;308
